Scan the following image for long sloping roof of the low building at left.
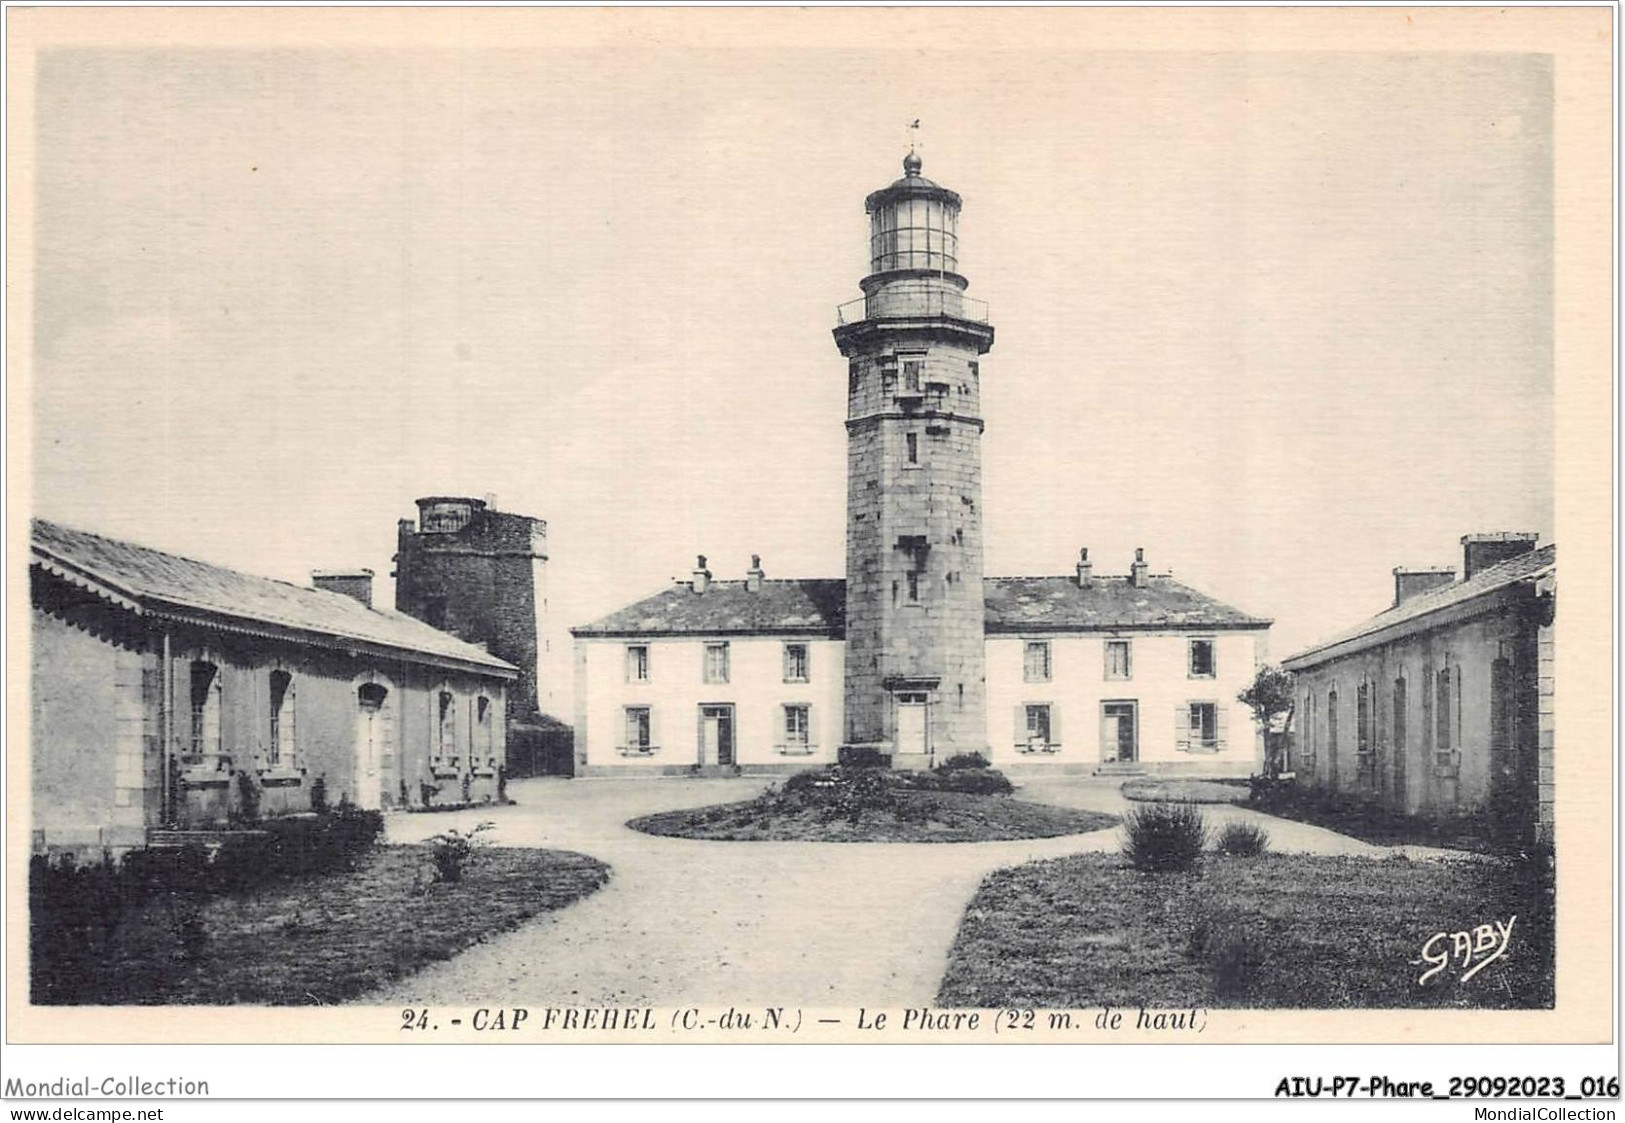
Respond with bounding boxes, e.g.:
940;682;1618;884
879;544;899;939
33;518;517;678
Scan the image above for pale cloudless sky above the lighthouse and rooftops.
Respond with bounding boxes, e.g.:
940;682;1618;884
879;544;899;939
22;46;1554;666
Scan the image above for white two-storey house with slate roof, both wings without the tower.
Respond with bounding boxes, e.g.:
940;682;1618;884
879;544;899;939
574;557;1269;775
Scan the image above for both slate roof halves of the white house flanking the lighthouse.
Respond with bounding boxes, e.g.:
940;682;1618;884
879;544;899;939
570;577;1269;639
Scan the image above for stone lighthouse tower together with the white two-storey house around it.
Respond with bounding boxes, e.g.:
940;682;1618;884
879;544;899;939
572;153;1271;775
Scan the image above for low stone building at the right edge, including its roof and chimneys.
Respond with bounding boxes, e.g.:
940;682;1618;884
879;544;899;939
1284;533;1557;842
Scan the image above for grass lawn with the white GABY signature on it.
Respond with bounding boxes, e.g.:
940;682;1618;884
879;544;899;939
936;853;1554;1009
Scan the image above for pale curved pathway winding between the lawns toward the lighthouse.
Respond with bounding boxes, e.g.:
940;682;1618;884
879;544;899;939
361;778;1475;1008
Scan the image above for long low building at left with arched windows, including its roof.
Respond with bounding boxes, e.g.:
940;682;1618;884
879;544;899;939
29;520;517;852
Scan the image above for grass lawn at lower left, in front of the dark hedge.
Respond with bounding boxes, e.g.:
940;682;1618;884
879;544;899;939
34;847;609;1006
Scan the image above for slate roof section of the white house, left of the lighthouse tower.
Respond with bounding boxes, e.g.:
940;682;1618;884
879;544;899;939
570;577;847;639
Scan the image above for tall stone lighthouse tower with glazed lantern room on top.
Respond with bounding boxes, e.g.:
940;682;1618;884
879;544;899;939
835;151;993;769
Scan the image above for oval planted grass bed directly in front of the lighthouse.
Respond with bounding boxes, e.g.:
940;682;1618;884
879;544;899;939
627;791;1118;842
